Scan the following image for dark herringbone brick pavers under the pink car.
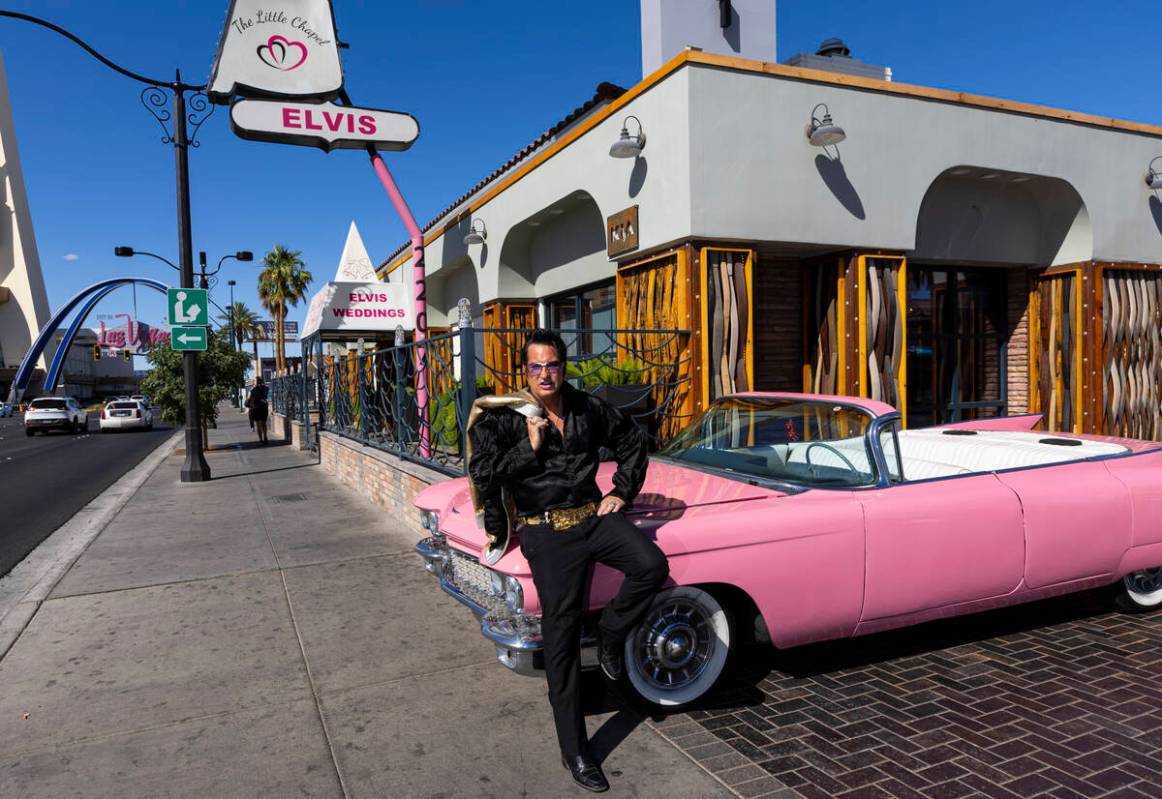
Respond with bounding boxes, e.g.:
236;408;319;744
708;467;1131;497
650;591;1162;799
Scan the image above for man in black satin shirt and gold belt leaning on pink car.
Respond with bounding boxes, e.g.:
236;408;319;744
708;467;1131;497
468;330;669;792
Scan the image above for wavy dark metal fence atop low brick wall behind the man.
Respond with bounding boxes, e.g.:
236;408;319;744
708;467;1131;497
278;326;694;475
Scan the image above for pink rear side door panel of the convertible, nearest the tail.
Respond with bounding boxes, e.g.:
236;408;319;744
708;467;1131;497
998;461;1133;588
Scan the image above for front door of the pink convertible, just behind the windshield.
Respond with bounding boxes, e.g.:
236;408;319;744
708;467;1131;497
859;474;1025;621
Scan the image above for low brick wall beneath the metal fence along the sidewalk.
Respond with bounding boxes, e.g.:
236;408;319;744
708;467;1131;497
271;415;449;540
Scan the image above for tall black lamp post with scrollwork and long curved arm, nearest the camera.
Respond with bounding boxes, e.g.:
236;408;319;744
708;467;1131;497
0;10;214;483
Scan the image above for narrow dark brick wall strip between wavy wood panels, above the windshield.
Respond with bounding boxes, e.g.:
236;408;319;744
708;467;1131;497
753;258;803;391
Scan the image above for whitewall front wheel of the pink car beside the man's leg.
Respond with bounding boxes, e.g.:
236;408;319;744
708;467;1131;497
625;585;733;707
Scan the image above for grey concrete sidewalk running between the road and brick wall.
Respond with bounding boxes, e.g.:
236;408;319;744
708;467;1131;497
0;410;732;799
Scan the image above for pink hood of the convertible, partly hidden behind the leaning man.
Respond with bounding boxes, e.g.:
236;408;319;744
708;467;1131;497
415;459;781;564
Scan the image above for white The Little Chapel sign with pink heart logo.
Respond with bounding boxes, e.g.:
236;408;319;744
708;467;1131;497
207;0;343;105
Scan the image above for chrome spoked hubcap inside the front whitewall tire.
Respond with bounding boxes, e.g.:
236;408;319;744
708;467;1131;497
634;600;717;689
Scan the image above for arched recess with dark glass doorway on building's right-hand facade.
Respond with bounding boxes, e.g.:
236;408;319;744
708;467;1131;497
906;165;1093;425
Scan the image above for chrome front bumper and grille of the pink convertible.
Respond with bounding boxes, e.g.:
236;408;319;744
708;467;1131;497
416;538;545;676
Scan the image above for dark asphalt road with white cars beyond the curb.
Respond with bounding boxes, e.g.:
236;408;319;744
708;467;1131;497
0;412;173;575
